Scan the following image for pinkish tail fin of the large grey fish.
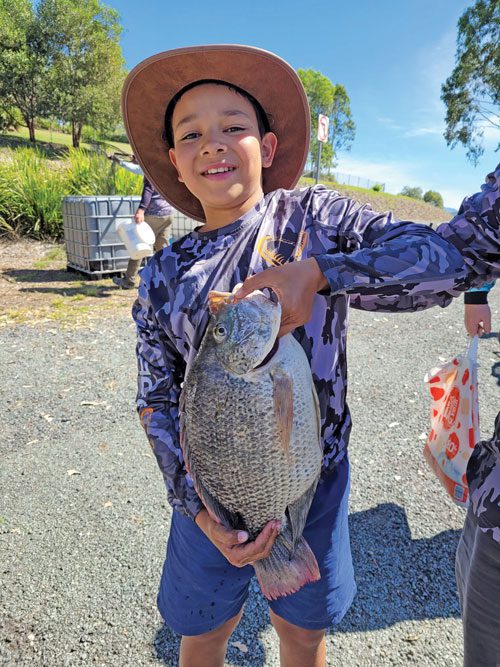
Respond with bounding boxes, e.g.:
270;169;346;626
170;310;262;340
253;533;321;600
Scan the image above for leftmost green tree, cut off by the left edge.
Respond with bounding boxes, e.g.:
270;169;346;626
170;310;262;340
0;0;48;142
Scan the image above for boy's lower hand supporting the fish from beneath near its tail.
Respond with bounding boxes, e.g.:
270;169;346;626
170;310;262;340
195;509;280;567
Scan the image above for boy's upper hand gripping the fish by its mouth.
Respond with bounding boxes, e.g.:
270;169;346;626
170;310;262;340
234;257;328;336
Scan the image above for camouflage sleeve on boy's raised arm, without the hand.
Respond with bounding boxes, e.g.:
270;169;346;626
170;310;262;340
313;190;467;310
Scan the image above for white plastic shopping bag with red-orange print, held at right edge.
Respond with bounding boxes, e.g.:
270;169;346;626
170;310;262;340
424;336;479;507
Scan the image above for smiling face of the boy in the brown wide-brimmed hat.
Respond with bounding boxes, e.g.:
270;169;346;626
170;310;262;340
169;84;277;224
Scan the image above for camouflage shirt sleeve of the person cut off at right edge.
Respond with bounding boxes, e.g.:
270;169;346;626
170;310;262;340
436;164;500;287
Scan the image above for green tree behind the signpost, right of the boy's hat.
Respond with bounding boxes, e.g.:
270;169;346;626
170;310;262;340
297;69;356;167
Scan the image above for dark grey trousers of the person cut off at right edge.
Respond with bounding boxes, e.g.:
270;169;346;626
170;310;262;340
455;508;500;667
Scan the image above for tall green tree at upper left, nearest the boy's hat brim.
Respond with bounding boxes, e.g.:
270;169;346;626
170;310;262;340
38;0;125;148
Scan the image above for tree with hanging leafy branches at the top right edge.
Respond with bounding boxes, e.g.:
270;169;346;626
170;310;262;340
441;0;500;164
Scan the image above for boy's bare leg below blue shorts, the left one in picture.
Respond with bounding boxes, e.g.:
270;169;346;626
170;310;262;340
179;610;243;667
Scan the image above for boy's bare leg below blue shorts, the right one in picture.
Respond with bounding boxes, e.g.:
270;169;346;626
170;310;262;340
269;610;326;667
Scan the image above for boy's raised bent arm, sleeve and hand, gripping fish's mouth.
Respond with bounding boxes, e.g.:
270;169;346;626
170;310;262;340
236;190;467;335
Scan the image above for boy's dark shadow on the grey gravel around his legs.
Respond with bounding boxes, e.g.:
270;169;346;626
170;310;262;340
154;503;460;667
